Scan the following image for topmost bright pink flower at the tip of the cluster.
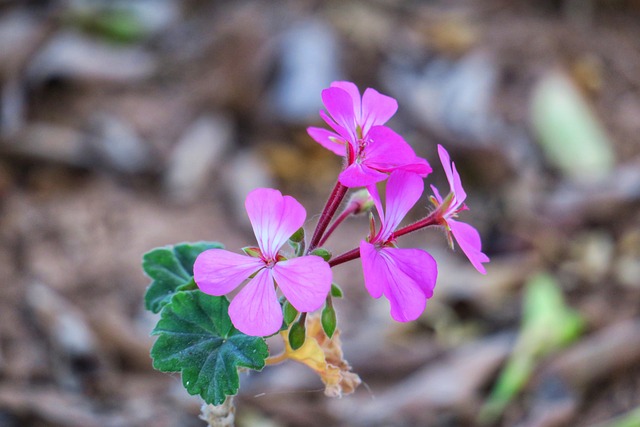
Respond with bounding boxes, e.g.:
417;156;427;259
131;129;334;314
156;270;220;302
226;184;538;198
307;82;431;188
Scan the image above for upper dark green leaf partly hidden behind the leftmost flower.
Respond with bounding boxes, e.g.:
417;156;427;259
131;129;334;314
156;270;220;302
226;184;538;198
142;242;223;313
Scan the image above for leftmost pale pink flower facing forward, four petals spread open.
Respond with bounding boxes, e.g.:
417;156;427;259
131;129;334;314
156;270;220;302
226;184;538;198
193;188;332;336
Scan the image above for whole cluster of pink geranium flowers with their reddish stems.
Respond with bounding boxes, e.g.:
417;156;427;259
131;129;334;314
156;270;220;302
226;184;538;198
194;82;489;336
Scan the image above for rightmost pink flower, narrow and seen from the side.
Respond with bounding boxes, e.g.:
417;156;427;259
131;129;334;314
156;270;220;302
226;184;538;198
431;145;489;274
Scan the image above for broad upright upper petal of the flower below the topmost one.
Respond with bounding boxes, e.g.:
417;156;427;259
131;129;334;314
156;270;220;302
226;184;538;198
380;170;424;240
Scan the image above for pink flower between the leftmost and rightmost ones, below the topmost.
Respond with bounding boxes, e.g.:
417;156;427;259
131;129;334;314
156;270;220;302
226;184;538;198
360;171;438;322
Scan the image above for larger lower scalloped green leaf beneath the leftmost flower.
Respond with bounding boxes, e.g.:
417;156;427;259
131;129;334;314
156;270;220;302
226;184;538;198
151;290;269;405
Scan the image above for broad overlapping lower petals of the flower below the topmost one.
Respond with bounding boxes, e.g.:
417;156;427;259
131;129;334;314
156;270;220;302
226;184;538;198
360;242;437;322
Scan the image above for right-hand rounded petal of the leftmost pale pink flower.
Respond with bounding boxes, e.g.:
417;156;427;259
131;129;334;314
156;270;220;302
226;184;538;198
273;255;333;312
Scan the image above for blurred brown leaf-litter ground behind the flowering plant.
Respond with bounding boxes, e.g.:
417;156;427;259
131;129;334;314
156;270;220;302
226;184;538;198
0;0;640;427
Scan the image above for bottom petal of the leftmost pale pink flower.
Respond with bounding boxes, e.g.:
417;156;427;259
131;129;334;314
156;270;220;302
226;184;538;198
229;268;282;337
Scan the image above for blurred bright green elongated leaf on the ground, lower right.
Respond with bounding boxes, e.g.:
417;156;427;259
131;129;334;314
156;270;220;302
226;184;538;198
479;273;584;424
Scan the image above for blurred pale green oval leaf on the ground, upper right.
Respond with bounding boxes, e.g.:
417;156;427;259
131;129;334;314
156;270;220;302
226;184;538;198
531;71;615;181
